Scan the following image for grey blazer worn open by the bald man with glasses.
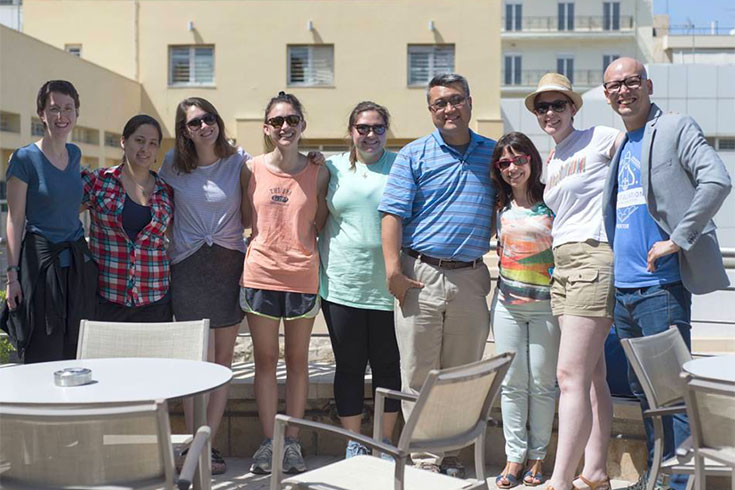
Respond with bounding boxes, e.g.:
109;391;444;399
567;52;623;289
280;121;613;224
603;104;732;294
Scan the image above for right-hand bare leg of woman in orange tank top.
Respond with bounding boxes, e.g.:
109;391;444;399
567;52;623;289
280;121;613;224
284;318;314;437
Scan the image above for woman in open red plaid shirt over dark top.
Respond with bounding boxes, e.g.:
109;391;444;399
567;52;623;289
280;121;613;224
82;114;173;322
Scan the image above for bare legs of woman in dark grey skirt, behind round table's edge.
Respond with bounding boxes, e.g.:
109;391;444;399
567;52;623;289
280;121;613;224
183;324;240;434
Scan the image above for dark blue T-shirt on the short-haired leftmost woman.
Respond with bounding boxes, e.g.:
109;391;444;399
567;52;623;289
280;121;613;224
6;143;84;243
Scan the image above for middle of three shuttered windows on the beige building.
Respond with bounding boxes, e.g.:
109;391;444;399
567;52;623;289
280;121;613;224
288;45;334;87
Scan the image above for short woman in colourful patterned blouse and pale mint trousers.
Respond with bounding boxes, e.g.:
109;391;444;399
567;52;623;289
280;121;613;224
490;133;560;488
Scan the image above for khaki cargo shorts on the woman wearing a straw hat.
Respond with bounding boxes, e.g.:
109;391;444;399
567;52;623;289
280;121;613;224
551;240;615;318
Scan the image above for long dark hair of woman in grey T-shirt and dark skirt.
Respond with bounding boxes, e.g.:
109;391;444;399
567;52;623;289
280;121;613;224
173;97;237;174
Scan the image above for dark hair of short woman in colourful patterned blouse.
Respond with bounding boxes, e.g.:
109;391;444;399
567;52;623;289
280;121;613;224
490;132;544;211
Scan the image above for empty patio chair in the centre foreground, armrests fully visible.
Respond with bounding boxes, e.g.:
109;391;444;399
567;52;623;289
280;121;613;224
271;353;513;490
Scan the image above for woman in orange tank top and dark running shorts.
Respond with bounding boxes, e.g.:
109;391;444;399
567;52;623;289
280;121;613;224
240;92;329;474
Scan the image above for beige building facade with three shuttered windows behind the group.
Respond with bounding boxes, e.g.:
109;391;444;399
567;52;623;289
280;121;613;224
14;0;503;153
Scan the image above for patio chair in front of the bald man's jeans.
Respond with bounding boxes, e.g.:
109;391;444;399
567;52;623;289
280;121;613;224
620;326;735;490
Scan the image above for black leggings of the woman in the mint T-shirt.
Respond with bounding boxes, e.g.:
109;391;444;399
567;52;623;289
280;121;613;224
322;299;401;417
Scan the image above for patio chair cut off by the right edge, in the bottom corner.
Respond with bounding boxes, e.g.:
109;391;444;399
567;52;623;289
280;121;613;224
682;373;735;490
